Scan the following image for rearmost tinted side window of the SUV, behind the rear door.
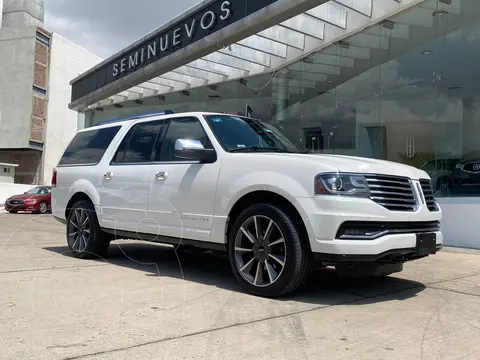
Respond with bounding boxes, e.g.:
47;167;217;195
59;126;120;166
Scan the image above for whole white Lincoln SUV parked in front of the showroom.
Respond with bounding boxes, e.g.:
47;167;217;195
52;112;443;297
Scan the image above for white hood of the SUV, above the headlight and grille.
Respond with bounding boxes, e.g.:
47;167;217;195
270;153;430;180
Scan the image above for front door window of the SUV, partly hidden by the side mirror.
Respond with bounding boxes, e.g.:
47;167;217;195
155;117;213;161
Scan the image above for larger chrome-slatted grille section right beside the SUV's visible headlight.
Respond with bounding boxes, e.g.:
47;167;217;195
365;175;417;211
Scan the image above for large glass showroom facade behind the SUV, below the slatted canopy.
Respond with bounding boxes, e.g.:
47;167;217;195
80;0;480;196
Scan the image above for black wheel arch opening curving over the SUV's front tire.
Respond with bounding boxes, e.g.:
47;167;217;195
225;190;313;250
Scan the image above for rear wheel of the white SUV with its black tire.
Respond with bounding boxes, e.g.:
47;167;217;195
67;200;110;259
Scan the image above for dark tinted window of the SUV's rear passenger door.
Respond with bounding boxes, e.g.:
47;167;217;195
113;121;163;164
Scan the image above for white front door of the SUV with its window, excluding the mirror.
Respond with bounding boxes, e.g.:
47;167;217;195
147;117;220;241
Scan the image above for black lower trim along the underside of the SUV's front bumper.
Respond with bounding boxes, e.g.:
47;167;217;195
313;245;443;264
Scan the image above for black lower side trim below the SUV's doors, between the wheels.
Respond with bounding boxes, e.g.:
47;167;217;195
101;228;227;252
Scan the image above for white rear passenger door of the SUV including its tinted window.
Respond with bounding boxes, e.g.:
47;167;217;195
100;120;163;233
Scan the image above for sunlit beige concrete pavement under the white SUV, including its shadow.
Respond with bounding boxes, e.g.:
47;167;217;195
0;214;480;360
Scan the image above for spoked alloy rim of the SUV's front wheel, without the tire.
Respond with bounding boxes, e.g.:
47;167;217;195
235;216;287;287
